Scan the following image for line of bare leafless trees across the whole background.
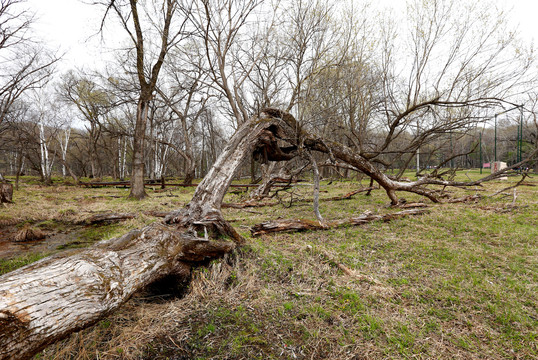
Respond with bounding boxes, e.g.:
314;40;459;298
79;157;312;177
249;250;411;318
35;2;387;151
0;0;538;195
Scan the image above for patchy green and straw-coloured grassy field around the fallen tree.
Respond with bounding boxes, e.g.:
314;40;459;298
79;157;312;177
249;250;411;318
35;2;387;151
0;172;538;359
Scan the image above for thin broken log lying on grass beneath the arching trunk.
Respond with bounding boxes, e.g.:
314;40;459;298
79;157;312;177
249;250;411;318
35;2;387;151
250;209;428;236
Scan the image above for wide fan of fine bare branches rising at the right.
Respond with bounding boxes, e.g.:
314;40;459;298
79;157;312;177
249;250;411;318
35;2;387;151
361;0;535;174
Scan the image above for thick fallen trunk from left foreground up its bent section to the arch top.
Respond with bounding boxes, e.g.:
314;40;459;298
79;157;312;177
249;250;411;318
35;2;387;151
0;109;292;360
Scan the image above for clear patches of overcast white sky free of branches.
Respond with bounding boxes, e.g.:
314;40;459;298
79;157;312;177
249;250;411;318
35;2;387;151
27;0;538;68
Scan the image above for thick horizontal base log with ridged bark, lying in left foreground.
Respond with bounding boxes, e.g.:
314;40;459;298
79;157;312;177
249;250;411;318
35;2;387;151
0;223;235;359
